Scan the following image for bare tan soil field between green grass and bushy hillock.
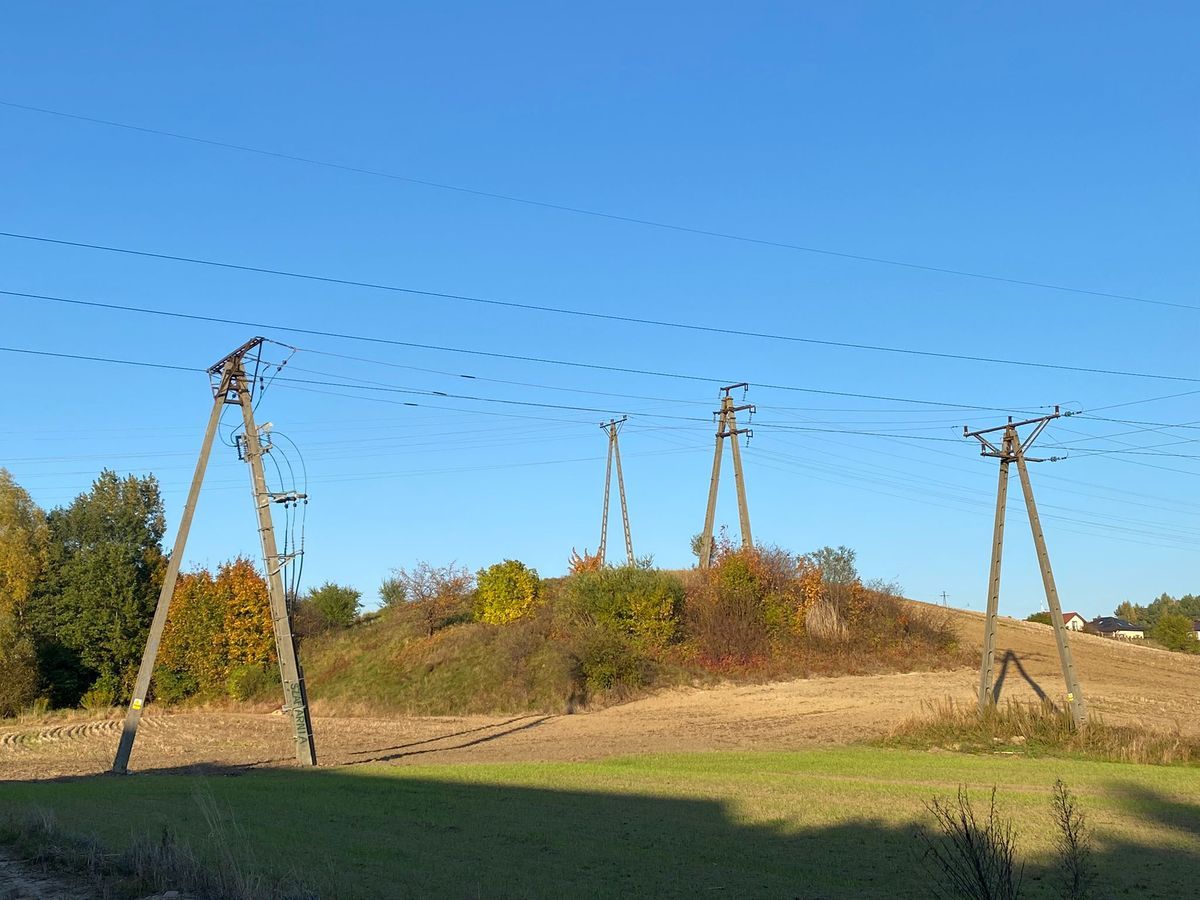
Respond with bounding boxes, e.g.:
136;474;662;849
0;612;1200;780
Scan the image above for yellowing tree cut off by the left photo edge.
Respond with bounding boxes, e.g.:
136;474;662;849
0;468;47;716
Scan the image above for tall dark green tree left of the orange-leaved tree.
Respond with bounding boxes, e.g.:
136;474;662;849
28;470;166;706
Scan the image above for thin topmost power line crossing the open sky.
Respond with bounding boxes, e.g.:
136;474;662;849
0;101;1200;310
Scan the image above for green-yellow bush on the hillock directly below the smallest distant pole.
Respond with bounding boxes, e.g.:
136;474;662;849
564;565;684;647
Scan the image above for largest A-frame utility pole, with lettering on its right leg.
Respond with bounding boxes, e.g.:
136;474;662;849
113;337;317;774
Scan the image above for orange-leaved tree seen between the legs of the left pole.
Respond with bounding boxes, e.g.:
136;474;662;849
155;557;276;701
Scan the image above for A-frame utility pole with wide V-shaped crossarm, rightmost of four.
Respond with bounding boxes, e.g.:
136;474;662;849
962;407;1087;726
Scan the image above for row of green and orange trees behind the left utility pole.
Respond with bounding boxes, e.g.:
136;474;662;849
0;468;359;715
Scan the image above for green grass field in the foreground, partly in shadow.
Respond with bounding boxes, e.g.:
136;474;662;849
0;748;1200;898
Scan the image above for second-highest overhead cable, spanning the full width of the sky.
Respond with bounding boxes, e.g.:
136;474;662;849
0;232;1200;384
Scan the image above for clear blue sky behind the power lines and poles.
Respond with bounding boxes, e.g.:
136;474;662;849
0;2;1200;614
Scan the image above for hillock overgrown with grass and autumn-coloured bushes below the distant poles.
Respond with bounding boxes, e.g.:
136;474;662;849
301;550;966;715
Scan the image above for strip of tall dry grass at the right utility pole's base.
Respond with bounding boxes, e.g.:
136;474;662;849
878;700;1200;766
